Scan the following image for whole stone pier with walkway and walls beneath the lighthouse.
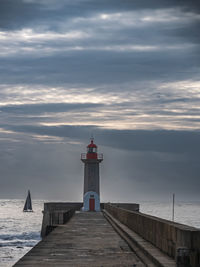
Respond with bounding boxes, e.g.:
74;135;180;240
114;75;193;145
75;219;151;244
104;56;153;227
15;203;200;267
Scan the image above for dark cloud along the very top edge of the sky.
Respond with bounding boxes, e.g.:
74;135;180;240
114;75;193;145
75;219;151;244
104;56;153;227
0;0;200;29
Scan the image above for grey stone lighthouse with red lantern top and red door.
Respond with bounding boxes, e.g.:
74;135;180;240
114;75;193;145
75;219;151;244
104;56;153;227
81;138;103;211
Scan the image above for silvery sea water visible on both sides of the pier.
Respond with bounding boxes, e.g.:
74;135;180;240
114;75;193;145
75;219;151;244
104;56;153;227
0;199;200;267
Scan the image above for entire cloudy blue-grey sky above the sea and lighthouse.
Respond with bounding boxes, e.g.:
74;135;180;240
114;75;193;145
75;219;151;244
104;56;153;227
0;0;200;202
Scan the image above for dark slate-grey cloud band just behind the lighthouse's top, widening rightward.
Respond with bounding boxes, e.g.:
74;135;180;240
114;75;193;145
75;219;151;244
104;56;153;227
2;125;200;154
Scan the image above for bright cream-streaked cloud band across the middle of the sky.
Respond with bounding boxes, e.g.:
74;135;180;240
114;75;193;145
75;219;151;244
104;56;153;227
0;80;200;130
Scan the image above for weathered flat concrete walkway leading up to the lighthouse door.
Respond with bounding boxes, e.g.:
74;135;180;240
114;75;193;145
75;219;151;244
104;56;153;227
15;212;144;267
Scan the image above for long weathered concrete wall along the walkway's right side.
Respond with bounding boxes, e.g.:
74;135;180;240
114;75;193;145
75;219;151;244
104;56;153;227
104;204;200;267
